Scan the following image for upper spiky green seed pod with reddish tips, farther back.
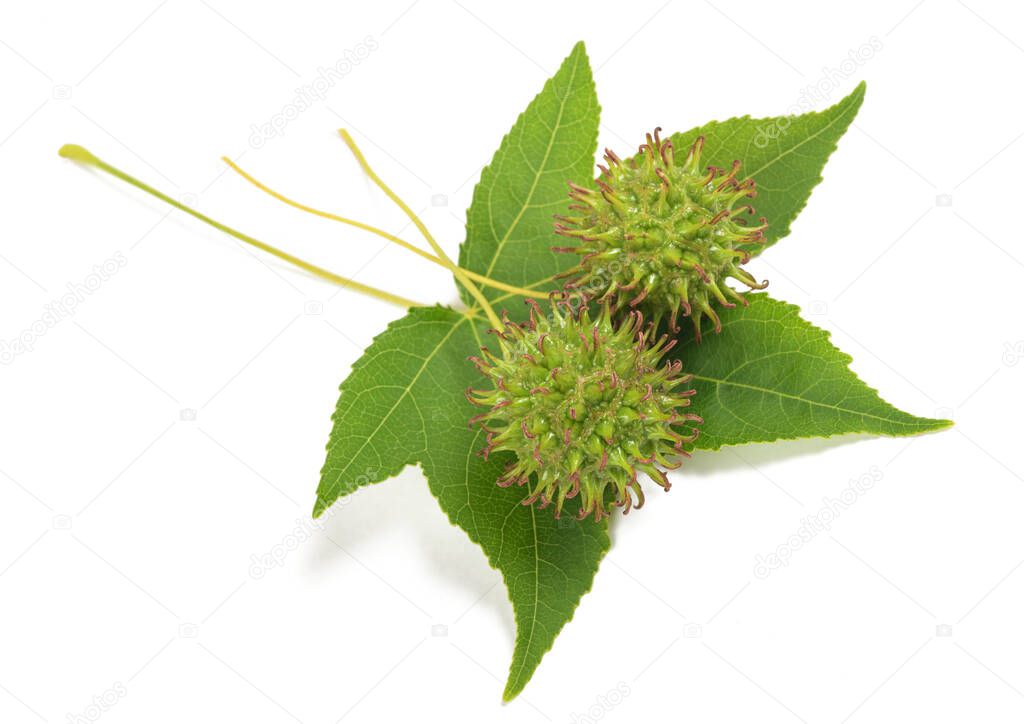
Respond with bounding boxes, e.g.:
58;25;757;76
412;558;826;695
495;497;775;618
555;128;767;339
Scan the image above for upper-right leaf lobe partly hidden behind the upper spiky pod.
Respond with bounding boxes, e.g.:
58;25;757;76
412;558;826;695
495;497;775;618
672;83;866;255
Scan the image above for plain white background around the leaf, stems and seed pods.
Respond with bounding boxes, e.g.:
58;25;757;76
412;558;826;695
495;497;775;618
0;0;1024;724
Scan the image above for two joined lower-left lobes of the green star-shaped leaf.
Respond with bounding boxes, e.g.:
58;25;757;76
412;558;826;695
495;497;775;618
313;306;610;699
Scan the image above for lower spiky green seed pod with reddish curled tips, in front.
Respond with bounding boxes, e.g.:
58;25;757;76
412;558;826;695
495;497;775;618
466;299;702;520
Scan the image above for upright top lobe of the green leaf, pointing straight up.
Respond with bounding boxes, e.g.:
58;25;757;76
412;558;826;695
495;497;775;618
459;43;601;312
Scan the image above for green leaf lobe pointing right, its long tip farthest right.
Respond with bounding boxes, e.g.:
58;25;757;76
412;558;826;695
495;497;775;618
678;294;952;450
